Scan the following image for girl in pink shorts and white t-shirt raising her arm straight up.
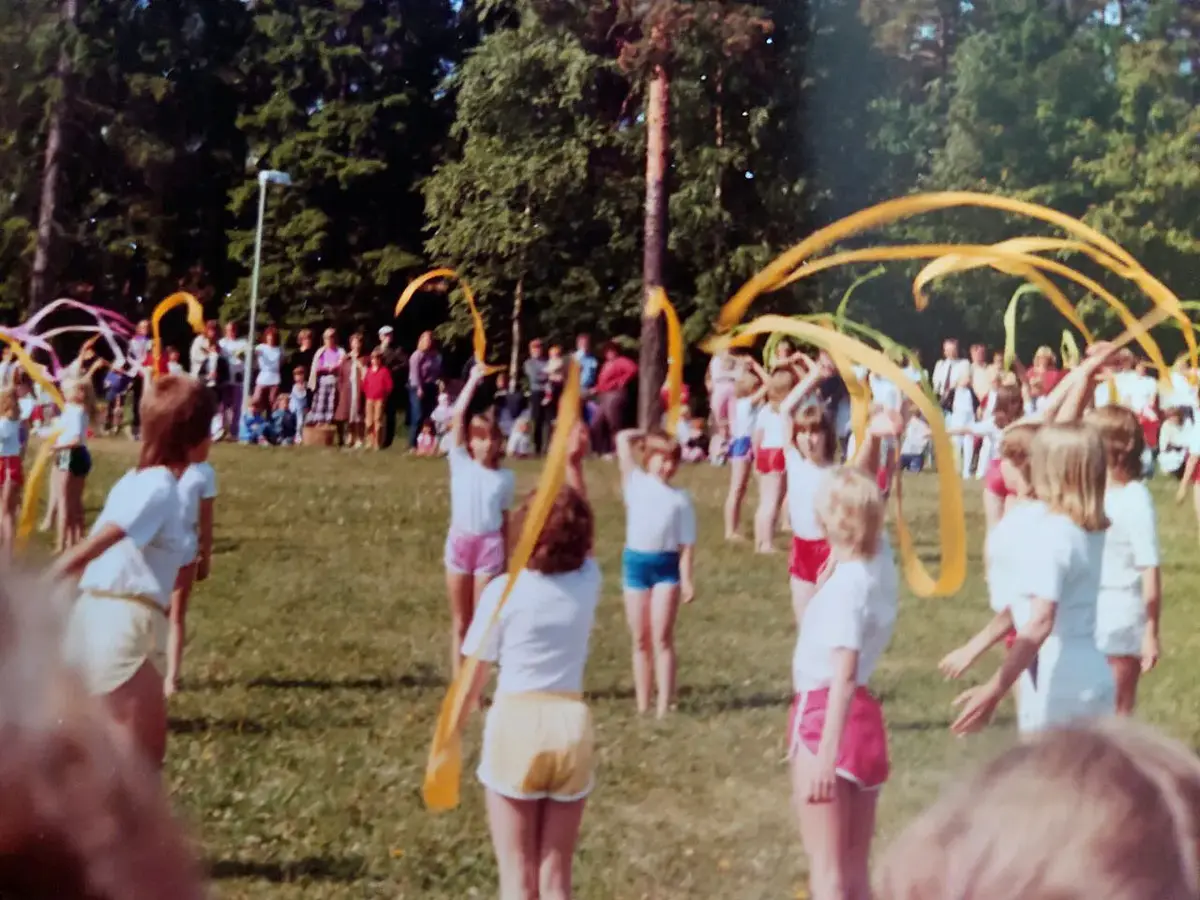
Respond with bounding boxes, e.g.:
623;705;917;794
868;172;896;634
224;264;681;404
444;366;515;674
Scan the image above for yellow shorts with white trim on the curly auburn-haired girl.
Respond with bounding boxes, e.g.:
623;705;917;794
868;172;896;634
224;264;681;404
476;694;595;803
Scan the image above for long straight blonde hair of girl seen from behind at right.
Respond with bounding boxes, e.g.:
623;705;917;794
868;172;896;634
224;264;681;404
1030;422;1109;532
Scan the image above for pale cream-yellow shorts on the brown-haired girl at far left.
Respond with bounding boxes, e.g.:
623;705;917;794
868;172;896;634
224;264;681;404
64;593;167;696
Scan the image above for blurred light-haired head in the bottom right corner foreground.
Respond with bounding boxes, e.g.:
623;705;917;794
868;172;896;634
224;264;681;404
878;720;1200;900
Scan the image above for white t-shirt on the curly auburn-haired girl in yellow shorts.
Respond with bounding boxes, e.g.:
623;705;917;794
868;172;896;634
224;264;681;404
462;559;601;694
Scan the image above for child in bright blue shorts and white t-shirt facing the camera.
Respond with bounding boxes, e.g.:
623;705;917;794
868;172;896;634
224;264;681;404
617;431;696;719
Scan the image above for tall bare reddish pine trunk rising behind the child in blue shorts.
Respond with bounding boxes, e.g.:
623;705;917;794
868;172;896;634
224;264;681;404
637;65;671;428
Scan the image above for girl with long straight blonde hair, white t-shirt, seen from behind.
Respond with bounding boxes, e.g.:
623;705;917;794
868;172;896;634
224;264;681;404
952;422;1116;734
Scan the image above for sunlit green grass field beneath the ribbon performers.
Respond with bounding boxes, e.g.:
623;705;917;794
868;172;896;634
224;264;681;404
72;442;1200;900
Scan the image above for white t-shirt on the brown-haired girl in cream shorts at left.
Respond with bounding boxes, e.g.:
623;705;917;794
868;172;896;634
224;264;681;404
79;467;196;610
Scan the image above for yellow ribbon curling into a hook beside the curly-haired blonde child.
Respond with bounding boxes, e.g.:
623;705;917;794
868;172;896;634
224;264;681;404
713;316;967;598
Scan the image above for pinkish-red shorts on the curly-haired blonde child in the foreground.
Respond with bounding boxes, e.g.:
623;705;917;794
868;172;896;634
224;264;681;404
787;686;890;791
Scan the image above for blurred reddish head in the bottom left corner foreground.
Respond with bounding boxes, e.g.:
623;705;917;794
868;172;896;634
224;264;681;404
0;572;204;900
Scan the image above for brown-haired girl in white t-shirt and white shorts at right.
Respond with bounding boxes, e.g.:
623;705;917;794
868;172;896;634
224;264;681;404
1085;406;1163;715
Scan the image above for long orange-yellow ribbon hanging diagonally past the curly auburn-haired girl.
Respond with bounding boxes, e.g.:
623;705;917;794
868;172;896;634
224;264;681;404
422;359;581;811
